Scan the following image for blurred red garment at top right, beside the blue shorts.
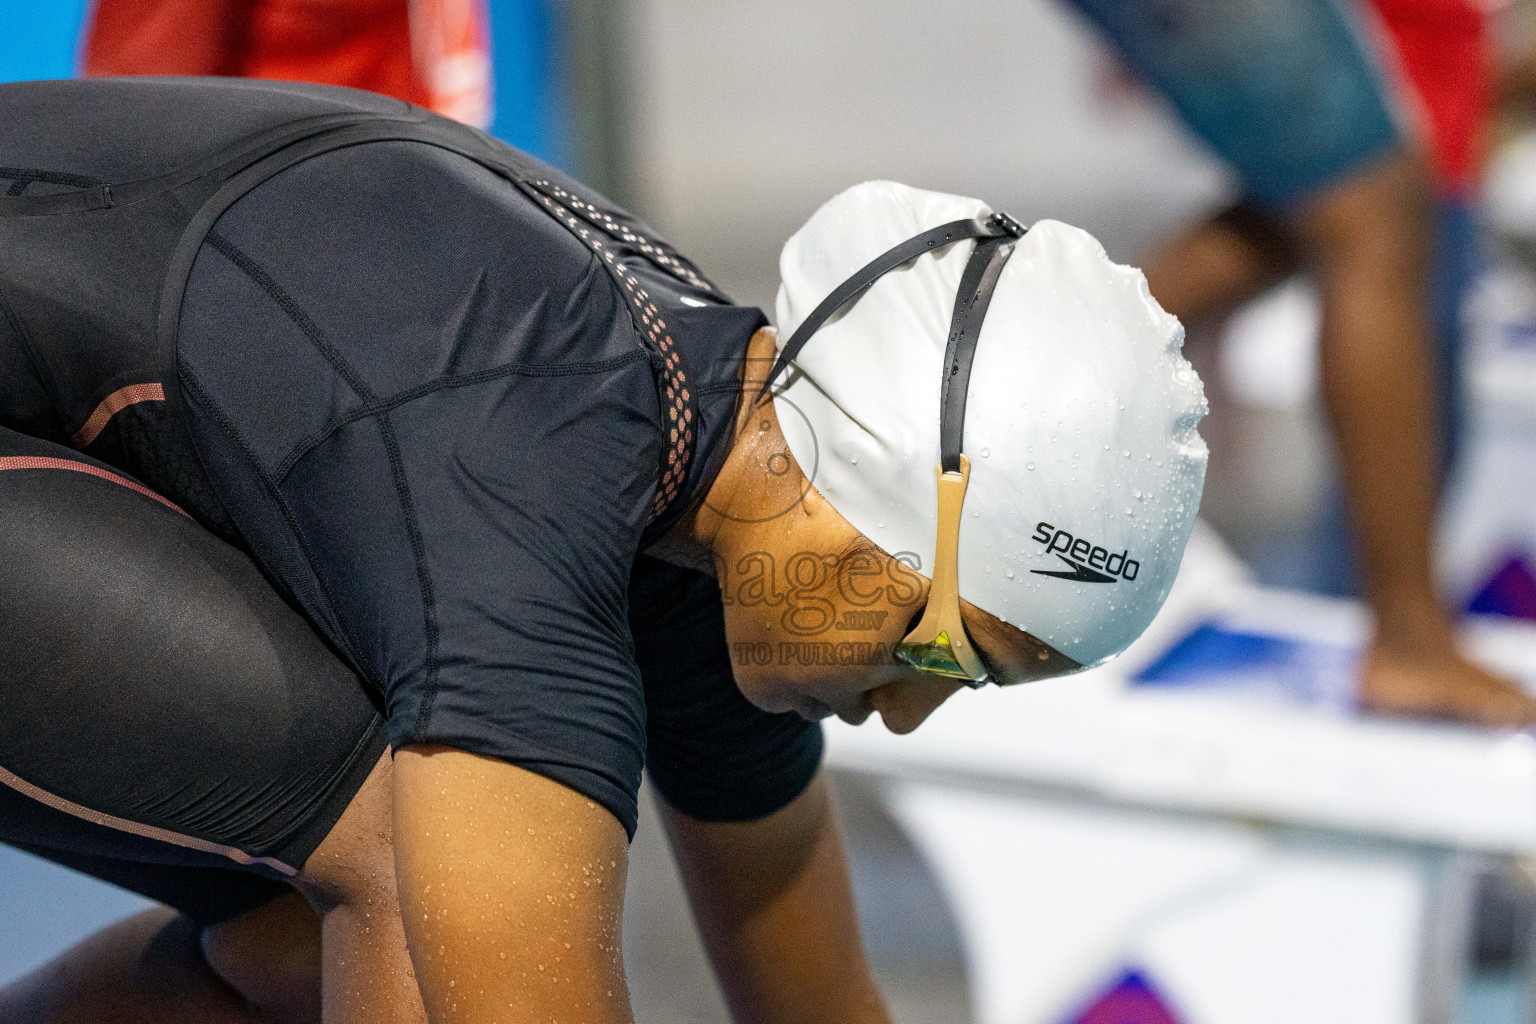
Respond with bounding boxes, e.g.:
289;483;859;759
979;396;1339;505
1372;0;1495;197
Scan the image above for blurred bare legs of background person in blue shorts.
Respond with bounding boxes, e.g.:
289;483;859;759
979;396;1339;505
1147;154;1536;725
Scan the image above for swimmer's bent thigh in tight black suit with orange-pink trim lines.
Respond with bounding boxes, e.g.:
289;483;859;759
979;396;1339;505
0;428;387;923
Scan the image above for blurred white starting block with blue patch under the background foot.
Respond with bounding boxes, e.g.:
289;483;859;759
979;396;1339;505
826;533;1536;1024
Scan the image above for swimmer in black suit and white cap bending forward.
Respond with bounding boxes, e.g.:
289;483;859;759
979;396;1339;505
0;80;1204;1024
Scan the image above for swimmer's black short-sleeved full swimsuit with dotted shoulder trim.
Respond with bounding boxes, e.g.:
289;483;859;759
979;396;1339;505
0;80;820;920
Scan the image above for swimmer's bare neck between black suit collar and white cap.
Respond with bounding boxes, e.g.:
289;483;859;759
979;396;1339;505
645;327;823;576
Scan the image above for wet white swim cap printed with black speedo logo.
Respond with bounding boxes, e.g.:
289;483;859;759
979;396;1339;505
774;181;1207;666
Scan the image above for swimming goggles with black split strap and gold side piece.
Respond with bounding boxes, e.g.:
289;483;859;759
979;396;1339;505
757;213;1029;689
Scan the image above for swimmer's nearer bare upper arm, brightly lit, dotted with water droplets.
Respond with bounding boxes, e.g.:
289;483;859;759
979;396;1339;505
395;746;631;1024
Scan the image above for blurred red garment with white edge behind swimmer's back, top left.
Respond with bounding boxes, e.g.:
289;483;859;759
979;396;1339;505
83;0;492;127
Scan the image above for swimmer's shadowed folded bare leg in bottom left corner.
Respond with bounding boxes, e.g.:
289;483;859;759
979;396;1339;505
0;894;319;1024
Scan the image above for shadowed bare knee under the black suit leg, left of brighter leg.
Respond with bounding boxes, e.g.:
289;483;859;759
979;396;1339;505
200;892;321;1024
